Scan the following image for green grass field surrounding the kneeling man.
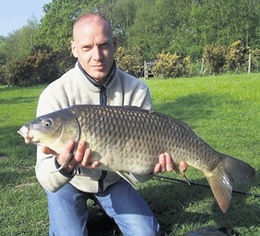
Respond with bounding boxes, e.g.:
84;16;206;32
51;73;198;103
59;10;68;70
0;73;260;236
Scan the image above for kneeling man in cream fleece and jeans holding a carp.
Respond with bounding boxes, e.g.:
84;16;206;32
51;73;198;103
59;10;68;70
36;13;187;236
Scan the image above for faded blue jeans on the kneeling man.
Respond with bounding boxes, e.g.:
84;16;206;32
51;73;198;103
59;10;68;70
46;179;159;236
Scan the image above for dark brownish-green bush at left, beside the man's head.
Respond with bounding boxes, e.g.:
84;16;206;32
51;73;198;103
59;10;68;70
0;45;75;86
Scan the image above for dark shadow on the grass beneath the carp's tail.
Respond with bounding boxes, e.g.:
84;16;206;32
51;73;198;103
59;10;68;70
145;173;260;233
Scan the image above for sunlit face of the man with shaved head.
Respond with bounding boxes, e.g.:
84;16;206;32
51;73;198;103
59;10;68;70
71;22;117;83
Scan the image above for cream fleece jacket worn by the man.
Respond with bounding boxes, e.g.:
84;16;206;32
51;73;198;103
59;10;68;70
35;61;151;193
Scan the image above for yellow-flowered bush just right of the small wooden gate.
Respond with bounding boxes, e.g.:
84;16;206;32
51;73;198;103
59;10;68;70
153;52;191;78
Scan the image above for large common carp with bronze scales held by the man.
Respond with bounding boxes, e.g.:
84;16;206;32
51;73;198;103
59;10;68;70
18;105;255;213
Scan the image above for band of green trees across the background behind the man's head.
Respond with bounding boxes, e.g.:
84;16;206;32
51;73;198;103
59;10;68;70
0;0;260;81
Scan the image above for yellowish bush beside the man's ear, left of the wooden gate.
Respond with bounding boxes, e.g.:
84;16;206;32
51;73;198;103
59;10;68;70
115;47;143;77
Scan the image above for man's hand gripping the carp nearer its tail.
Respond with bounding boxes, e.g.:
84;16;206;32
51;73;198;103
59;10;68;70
153;152;188;174
